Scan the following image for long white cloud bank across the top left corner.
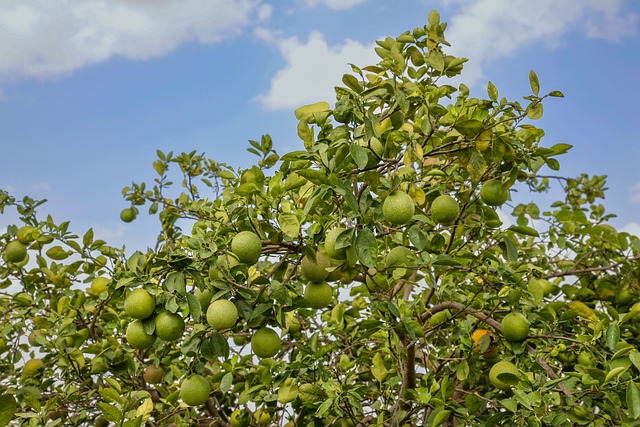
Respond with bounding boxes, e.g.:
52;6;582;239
0;0;262;80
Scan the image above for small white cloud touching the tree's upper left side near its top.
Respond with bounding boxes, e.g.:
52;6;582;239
256;30;378;110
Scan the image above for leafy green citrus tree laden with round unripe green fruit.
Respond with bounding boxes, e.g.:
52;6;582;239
0;11;640;427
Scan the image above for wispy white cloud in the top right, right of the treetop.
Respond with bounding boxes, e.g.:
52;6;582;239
443;0;638;84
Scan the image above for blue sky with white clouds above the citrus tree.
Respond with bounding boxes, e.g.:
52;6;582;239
0;0;640;249
